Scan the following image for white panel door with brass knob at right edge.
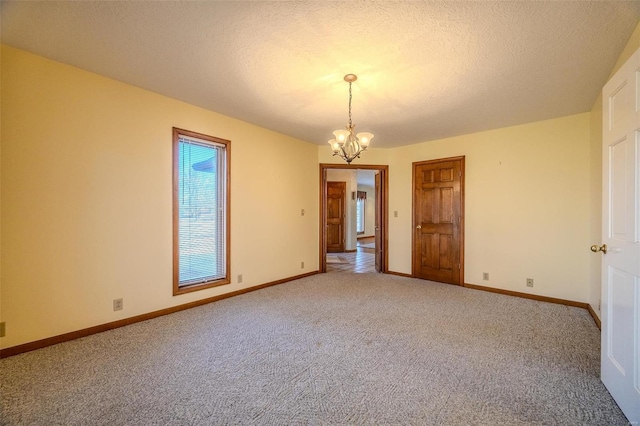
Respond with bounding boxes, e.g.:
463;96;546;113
604;46;640;424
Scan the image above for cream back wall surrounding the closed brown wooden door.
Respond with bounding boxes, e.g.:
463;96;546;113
319;113;590;302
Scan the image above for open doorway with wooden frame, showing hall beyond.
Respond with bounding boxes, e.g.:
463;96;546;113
319;164;388;273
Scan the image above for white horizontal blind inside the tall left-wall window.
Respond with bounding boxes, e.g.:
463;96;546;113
176;135;228;287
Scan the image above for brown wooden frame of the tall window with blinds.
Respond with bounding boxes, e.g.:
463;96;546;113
172;127;231;296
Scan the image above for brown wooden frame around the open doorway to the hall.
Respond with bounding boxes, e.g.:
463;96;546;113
318;163;389;273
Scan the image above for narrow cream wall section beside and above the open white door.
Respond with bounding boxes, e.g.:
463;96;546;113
589;22;640;317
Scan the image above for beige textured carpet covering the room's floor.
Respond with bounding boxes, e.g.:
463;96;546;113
0;273;627;425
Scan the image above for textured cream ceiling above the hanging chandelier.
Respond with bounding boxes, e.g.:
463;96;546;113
1;0;640;147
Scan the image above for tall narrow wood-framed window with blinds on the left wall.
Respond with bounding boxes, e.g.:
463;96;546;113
173;128;231;295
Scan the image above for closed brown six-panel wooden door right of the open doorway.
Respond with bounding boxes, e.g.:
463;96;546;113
412;157;464;285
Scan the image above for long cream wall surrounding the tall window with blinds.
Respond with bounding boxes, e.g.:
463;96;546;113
0;46;319;348
